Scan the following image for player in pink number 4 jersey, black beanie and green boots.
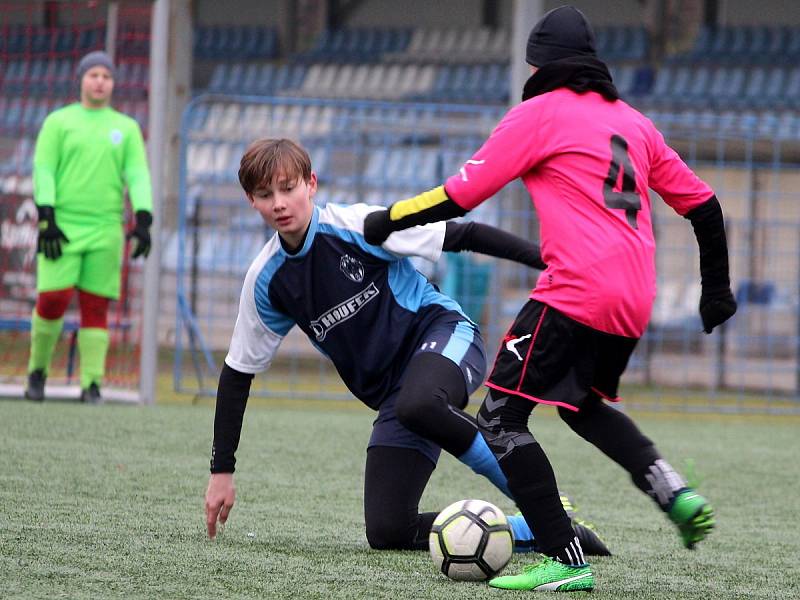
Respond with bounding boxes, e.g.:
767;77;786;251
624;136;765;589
364;6;736;591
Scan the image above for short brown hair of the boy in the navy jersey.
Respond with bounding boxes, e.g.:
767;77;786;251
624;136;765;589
239;138;311;194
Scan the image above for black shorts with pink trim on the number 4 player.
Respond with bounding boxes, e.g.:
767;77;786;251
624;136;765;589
486;300;639;411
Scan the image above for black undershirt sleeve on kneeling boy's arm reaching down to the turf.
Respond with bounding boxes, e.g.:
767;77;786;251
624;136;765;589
211;364;253;473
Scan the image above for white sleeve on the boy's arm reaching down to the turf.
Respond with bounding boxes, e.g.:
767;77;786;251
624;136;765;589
225;243;290;373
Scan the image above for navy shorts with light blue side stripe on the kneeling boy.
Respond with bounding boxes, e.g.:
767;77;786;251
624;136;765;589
367;315;486;464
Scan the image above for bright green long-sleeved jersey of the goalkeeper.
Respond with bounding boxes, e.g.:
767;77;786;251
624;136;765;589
33;103;153;227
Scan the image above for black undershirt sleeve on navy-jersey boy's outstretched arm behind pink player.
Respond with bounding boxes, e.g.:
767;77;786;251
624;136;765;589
442;221;547;269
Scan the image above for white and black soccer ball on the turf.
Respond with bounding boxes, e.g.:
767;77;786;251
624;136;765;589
428;500;514;581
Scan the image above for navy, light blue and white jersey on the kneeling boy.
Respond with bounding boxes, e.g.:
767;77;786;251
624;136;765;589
225;204;476;408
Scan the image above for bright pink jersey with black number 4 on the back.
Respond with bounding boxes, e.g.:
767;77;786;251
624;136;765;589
445;88;714;338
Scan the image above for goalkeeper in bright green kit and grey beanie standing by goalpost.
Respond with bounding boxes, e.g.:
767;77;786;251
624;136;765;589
25;51;153;403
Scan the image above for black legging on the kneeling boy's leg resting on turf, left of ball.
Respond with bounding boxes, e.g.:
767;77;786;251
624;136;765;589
364;446;437;550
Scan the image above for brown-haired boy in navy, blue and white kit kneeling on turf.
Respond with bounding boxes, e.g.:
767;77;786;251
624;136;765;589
206;139;608;554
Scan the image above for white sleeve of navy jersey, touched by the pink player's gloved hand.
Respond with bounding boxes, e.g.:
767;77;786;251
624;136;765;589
326;204;445;262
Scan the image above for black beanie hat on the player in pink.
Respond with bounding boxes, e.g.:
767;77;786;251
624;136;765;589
525;6;597;67
